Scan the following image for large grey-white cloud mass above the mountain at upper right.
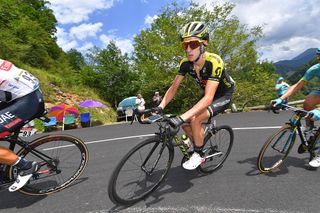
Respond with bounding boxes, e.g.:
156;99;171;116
191;0;320;61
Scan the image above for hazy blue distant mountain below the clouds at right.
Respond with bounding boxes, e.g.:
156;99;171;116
274;48;317;77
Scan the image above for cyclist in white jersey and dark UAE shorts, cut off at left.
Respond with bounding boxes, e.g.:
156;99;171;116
0;59;44;191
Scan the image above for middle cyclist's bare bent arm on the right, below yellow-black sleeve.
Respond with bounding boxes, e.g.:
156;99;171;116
181;81;219;121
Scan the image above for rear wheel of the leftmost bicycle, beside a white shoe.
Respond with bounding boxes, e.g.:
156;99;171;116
9;134;89;195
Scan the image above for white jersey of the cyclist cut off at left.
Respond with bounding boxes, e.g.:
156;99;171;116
0;59;39;100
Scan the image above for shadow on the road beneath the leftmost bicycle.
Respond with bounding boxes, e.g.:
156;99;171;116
0;177;89;212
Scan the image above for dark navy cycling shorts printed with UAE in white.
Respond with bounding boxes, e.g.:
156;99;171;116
0;89;45;133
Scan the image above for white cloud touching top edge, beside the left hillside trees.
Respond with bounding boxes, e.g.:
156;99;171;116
49;0;117;24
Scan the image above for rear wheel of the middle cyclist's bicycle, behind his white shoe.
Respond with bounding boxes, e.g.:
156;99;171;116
197;125;234;174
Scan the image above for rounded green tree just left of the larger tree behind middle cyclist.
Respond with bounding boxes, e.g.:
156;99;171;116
81;41;139;106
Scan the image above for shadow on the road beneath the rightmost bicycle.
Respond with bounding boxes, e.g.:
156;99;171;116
238;156;317;177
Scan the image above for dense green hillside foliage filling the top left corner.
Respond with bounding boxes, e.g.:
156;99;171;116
0;0;63;68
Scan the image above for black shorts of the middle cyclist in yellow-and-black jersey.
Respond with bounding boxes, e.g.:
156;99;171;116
207;88;234;119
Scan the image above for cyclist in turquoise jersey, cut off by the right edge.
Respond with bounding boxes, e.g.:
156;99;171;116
272;48;320;167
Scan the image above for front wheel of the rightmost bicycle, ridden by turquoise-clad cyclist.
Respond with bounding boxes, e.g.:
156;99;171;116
257;125;297;173
